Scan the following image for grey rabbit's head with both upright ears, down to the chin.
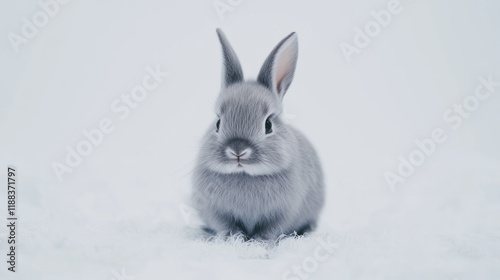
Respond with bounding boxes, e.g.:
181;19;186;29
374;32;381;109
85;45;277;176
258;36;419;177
200;29;298;175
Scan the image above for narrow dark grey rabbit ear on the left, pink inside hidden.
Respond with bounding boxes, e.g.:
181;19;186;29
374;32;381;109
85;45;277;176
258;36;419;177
217;28;243;87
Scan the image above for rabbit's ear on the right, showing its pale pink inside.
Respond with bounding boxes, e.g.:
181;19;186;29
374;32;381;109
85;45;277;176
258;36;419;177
257;32;299;98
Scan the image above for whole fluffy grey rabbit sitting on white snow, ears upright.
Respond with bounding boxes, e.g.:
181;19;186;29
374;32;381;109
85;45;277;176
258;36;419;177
192;29;324;240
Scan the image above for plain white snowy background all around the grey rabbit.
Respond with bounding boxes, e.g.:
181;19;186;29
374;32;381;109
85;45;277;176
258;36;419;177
0;0;500;280
